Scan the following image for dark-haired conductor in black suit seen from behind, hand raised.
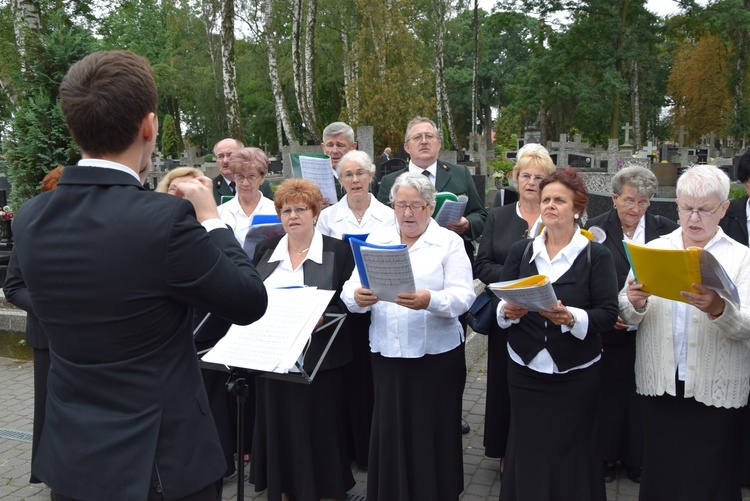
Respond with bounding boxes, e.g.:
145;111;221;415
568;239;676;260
9;51;267;501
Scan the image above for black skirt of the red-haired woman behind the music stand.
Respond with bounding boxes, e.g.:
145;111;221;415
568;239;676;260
250;368;355;501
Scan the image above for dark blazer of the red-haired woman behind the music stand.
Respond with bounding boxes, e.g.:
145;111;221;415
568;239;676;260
253;235;354;373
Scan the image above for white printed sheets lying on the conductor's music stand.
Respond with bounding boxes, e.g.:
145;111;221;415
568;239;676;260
202;287;335;374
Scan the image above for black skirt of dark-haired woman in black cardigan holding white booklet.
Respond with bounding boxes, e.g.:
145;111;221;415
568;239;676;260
500;361;606;501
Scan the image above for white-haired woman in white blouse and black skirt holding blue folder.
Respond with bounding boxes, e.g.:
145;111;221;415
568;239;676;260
341;172;475;501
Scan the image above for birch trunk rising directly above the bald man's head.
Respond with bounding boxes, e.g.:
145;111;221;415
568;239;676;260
221;0;245;142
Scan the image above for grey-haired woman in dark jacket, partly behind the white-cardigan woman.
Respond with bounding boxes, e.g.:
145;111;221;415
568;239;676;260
586;167;678;482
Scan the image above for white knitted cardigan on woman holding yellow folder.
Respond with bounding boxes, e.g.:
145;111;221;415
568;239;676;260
619;228;750;408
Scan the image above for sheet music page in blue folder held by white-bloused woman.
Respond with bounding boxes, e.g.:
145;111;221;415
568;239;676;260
360;247;417;303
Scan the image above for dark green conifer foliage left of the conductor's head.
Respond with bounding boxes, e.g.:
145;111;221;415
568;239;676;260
3;10;96;207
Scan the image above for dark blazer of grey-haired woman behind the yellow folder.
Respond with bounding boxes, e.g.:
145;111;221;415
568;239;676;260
585;209;680;344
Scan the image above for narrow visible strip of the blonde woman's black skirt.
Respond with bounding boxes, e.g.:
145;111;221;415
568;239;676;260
484;326;510;458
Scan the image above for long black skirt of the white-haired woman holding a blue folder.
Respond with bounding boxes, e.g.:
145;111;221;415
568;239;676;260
367;344;466;501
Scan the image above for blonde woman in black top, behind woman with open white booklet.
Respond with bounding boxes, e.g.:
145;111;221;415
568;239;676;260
475;143;555;474
